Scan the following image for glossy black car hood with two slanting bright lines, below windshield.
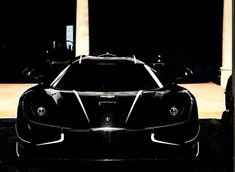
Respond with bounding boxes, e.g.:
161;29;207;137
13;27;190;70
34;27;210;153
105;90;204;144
40;89;192;129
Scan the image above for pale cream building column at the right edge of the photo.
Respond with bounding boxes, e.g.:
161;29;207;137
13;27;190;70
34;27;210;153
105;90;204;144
220;0;232;87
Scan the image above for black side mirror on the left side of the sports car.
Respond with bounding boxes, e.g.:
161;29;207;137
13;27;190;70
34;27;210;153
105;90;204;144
22;68;45;82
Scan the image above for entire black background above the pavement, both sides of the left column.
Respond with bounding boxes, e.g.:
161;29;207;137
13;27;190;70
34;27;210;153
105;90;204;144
0;0;223;82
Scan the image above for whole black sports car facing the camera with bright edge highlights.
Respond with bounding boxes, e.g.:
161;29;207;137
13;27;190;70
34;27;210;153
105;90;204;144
16;55;200;160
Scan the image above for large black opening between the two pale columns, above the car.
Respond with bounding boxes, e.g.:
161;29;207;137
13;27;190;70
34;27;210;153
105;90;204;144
89;0;223;82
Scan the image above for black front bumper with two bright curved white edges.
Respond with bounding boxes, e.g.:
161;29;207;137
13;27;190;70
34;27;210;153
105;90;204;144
16;121;200;161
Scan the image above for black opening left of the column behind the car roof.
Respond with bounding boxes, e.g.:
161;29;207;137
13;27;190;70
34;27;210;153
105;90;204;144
0;0;76;82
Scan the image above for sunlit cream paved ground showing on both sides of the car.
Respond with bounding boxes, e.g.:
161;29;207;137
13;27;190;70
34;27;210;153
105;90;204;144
0;82;225;119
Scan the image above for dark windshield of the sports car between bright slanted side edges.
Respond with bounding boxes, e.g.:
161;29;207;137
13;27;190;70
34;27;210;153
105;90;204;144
52;63;162;92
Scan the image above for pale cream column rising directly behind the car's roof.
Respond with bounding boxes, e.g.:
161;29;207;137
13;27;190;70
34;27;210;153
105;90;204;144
75;0;89;56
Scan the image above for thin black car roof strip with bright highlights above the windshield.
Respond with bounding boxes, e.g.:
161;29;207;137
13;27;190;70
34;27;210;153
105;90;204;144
72;55;145;64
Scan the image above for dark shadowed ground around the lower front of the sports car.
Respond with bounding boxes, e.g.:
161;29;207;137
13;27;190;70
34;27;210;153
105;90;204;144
0;119;234;172
